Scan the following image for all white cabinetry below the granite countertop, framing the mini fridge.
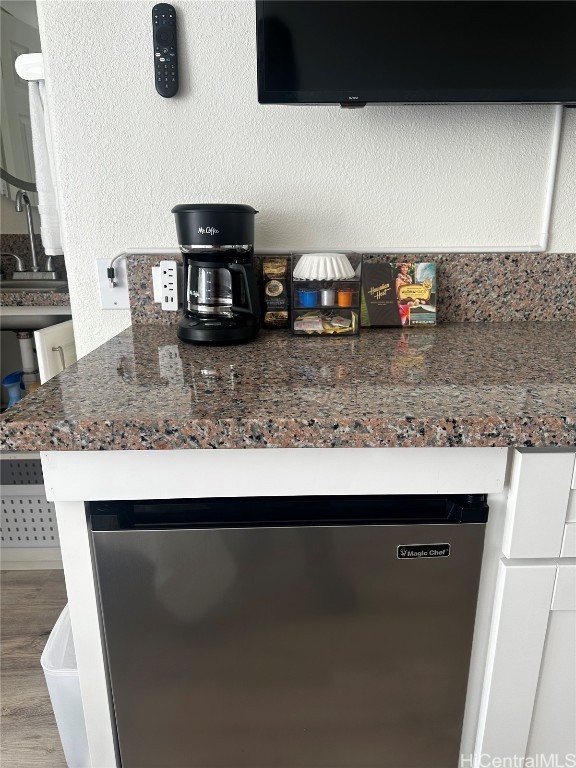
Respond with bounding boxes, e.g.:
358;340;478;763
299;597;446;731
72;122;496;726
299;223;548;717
42;448;576;768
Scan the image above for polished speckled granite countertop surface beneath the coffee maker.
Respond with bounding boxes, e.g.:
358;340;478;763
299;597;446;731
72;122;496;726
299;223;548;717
0;322;576;451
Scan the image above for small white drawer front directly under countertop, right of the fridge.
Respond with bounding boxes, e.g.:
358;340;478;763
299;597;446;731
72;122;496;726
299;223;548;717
502;450;575;558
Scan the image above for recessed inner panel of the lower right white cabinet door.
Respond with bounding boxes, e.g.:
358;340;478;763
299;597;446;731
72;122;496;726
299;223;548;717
526;610;576;766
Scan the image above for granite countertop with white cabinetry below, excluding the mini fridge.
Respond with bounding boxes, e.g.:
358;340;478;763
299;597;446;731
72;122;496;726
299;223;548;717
0;322;576;768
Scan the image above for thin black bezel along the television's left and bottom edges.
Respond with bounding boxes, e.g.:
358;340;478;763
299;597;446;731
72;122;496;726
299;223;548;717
256;0;576;107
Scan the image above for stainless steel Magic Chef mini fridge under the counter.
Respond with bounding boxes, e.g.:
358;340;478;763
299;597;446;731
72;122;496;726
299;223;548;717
88;496;488;768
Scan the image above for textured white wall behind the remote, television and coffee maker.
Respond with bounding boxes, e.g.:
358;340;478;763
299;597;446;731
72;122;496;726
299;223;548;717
39;0;576;354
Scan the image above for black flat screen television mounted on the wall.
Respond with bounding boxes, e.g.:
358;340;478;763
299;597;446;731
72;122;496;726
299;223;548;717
256;0;576;106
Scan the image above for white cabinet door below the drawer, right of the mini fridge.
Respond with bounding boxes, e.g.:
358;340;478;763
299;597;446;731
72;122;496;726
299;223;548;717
472;561;576;768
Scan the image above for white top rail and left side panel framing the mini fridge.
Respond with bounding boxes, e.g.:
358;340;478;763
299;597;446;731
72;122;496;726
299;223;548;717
42;448;507;768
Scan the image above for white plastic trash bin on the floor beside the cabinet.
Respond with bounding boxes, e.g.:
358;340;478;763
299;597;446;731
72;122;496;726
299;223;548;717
40;606;90;768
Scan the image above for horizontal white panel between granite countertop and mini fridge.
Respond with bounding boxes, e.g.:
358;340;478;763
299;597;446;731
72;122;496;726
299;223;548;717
42;448;507;501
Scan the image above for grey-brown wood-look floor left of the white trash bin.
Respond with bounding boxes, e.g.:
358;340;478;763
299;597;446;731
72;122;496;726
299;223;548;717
0;570;66;768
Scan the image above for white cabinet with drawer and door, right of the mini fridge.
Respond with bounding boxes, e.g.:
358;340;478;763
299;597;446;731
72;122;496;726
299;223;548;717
472;451;576;768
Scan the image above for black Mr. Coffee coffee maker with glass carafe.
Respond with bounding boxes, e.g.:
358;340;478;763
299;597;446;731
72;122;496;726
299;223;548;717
172;204;260;344
